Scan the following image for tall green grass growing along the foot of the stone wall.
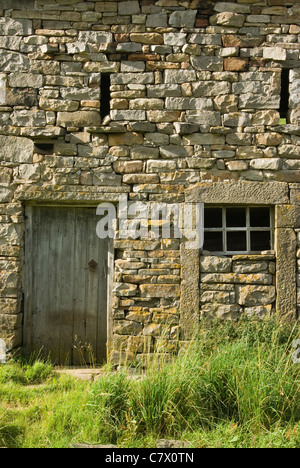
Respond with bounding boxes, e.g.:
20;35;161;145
0;320;300;447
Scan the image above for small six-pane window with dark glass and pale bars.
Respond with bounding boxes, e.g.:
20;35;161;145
204;206;273;255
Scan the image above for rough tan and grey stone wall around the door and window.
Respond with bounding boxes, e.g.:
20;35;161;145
0;0;300;362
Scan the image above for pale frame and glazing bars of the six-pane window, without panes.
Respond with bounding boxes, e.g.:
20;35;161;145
204;204;274;256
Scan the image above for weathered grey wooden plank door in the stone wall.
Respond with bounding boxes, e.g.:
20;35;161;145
24;206;108;365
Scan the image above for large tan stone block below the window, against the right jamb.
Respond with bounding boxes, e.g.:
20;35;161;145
236;285;276;306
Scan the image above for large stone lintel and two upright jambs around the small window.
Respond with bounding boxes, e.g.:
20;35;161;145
180;181;300;340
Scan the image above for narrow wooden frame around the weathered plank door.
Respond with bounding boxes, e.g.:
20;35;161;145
23;202;115;360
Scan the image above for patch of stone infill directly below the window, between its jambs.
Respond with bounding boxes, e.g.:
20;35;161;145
200;255;276;320
